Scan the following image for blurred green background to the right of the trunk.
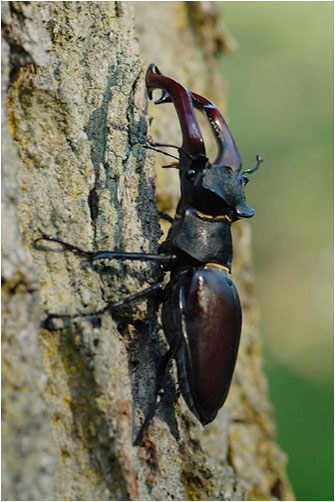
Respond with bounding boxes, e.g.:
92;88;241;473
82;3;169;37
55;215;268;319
218;2;334;500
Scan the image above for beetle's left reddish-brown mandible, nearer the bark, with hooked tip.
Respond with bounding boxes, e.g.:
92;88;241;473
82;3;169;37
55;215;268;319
146;63;206;157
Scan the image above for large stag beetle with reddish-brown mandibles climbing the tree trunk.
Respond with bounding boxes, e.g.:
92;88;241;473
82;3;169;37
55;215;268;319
36;64;263;445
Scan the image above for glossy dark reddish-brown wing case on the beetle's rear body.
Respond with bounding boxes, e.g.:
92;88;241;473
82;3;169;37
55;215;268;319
162;265;242;425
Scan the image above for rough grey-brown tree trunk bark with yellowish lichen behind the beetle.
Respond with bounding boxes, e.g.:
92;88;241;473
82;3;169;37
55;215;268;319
2;2;292;500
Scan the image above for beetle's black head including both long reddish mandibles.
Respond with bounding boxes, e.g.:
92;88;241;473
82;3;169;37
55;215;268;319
146;64;263;221
